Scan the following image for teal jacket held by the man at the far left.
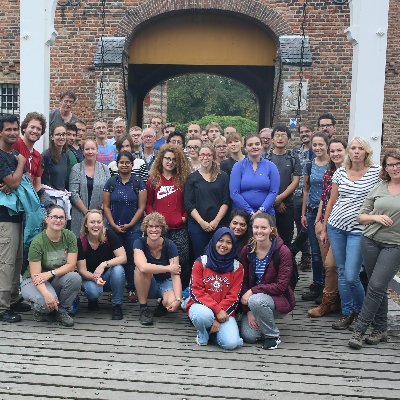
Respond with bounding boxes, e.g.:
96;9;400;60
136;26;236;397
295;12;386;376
0;175;44;247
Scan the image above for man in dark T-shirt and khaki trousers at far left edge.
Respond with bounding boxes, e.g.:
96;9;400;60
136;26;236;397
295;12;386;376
0;115;26;322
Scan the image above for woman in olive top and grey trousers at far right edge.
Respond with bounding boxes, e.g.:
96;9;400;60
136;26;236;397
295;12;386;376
349;151;400;349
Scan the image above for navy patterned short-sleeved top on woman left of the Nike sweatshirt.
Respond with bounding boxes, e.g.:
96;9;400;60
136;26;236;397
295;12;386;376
103;175;146;225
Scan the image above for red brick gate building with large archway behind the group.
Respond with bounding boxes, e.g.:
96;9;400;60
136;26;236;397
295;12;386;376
0;0;400;147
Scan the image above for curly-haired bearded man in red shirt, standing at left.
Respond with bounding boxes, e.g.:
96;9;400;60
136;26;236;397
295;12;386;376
13;112;46;192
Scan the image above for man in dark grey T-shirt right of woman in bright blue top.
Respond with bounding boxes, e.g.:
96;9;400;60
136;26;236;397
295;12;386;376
267;125;302;247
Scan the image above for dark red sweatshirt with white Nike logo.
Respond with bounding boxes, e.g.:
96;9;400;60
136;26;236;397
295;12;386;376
146;175;187;229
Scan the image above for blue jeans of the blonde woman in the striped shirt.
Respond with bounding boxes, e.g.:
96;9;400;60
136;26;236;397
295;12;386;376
327;224;365;315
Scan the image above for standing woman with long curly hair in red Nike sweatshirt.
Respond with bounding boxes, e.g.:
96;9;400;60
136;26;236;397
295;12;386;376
146;144;191;288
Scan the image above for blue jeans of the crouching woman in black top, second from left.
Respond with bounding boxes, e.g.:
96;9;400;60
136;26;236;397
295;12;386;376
82;265;125;306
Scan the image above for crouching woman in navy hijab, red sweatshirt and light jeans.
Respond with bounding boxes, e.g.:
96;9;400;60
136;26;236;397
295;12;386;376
186;228;243;350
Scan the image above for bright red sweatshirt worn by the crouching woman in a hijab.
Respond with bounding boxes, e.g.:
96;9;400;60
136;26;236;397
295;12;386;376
186;256;243;315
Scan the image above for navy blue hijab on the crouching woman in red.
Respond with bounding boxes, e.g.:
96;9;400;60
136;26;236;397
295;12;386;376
206;228;237;274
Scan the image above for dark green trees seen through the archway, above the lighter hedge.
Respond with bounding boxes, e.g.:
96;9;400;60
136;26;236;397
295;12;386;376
167;74;258;124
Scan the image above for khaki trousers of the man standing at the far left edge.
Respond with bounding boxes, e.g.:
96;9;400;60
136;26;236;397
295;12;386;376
0;222;23;312
